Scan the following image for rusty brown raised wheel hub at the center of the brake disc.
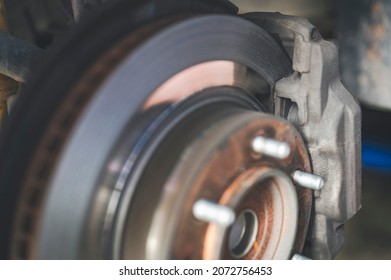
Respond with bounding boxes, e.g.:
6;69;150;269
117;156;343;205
122;110;311;259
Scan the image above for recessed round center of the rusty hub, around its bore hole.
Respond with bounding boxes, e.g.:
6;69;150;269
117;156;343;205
216;167;299;259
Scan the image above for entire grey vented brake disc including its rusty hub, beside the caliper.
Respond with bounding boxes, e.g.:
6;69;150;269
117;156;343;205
0;1;311;259
